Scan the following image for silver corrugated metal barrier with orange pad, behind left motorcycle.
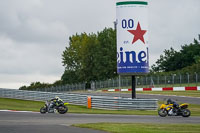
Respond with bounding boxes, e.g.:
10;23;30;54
0;89;158;110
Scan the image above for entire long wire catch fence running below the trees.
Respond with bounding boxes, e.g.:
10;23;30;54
25;73;200;93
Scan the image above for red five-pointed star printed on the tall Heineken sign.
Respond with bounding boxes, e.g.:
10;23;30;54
128;22;147;44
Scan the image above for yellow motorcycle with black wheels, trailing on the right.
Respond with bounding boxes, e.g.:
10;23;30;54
158;103;191;117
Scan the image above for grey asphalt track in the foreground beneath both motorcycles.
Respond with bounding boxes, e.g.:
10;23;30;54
0;112;200;133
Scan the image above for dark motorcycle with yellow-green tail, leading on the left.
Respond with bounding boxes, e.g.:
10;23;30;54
40;100;68;114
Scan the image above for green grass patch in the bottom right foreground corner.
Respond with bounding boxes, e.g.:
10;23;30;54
73;123;200;133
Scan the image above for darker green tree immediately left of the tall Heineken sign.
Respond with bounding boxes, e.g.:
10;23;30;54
94;28;117;80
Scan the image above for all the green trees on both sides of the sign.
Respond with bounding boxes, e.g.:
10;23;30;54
20;28;200;90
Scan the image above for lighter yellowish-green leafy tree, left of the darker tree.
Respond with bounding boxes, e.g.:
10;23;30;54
61;33;97;83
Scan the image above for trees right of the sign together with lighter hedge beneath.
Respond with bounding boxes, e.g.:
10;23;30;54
150;39;200;75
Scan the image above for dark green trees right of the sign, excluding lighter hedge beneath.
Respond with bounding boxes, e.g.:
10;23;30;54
151;39;200;72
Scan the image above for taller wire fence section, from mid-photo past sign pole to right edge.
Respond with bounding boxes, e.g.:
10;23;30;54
91;73;200;90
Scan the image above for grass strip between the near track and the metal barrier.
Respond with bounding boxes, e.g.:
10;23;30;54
0;98;200;116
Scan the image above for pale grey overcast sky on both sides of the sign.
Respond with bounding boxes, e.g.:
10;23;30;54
0;0;200;89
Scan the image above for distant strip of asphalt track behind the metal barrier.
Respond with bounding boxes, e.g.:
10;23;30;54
72;92;200;104
